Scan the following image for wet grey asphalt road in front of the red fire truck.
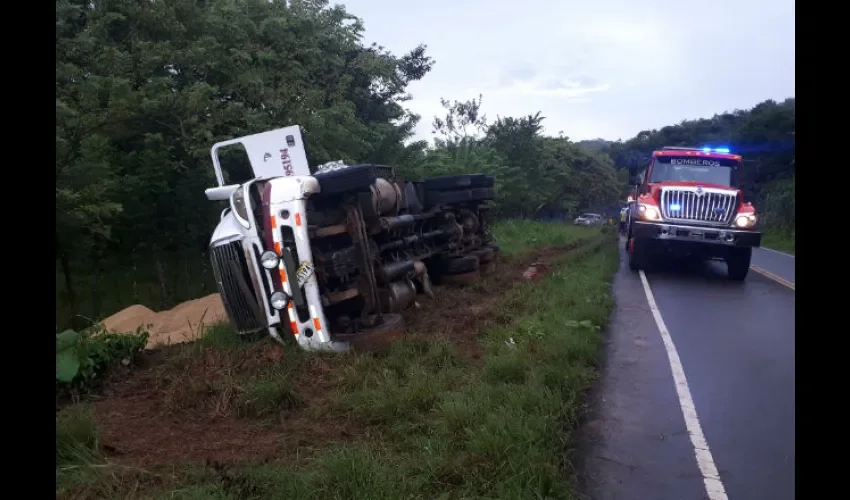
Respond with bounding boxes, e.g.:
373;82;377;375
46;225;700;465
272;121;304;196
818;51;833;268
581;245;795;500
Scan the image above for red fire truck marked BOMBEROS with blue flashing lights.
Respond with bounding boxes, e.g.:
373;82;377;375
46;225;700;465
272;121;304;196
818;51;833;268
626;147;761;281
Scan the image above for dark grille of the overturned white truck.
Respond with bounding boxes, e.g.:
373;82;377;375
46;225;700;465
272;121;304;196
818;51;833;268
210;241;264;333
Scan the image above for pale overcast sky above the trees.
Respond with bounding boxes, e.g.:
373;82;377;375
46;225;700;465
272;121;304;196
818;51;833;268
332;0;794;144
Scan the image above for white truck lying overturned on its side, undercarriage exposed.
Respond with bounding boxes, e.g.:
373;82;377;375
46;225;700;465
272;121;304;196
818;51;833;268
206;125;498;351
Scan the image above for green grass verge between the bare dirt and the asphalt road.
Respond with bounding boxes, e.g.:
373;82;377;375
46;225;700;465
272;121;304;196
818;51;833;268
57;221;618;500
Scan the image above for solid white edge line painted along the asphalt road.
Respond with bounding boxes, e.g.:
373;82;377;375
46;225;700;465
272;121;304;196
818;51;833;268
640;270;729;500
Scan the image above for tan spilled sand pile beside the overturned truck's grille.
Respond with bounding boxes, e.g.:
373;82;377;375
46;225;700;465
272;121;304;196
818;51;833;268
103;293;227;349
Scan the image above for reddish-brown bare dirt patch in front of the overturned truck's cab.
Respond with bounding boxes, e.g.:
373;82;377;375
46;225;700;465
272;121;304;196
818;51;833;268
93;341;362;467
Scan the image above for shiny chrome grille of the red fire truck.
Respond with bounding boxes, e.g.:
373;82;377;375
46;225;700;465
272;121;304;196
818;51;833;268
661;188;737;224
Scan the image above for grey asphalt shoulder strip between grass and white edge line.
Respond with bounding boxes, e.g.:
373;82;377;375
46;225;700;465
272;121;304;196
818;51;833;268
578;242;705;500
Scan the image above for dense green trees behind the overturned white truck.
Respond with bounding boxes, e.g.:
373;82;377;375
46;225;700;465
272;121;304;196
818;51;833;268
56;0;623;329
